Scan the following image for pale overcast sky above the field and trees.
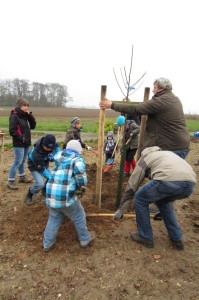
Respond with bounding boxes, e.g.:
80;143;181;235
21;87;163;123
0;0;199;113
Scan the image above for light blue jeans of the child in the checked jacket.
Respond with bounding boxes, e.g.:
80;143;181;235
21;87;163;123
43;200;91;248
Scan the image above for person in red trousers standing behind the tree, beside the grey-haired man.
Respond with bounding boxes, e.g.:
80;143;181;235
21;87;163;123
123;116;140;177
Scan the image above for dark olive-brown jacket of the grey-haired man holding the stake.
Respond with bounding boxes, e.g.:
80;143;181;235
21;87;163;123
111;91;190;151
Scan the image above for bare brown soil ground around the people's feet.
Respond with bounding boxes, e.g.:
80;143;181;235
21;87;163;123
0;138;199;300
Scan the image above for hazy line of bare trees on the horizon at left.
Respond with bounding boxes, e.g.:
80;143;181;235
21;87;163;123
0;78;72;107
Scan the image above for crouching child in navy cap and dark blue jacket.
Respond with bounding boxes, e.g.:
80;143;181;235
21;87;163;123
24;134;60;205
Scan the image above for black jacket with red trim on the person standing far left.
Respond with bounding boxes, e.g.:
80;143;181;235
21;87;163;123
9;107;36;147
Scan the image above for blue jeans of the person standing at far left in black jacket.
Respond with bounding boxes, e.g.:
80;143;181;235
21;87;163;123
8;147;29;181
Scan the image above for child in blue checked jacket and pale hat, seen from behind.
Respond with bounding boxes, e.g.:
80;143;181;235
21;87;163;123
43;140;95;252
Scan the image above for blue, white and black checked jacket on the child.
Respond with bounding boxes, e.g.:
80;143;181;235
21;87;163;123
46;149;87;208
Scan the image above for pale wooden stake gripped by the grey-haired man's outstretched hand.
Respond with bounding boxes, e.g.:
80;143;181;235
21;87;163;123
94;85;107;208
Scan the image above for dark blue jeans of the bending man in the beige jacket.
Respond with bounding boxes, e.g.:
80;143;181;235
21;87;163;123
134;180;195;241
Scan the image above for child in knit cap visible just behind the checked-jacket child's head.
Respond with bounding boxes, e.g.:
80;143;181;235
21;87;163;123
63;117;91;150
